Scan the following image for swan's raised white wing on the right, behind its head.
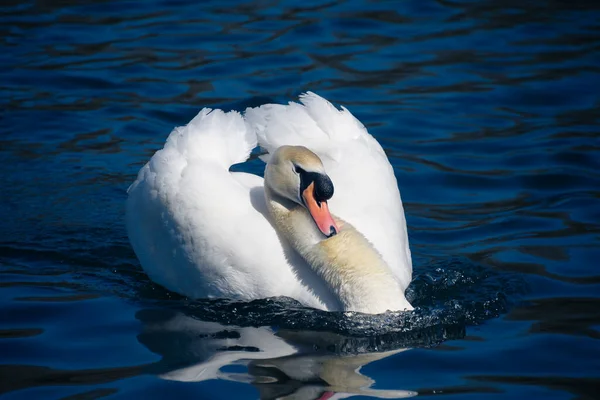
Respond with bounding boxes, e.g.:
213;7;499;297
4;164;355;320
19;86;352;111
245;92;412;289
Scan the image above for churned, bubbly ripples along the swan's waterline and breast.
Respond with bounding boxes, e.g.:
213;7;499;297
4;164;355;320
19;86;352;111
120;261;526;352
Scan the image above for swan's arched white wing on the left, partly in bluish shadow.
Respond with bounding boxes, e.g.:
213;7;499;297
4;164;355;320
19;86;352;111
126;109;333;308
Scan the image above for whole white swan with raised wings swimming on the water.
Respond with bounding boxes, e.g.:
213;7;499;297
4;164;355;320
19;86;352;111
127;93;412;313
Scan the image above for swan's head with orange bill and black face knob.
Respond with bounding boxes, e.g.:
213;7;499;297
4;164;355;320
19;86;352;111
265;146;339;237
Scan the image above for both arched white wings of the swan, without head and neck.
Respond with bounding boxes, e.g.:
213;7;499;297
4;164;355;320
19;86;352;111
126;93;412;310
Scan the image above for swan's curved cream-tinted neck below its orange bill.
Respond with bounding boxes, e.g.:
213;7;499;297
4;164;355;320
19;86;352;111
265;186;412;314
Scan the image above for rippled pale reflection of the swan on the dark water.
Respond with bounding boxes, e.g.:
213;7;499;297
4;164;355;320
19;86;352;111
138;310;416;399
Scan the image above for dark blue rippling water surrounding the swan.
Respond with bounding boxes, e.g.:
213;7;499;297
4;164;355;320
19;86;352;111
0;0;600;399
